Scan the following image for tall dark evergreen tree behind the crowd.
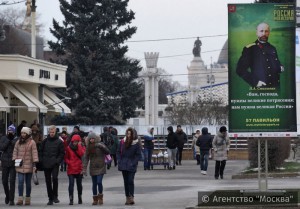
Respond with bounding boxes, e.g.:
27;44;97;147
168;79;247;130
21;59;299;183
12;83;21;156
48;0;142;124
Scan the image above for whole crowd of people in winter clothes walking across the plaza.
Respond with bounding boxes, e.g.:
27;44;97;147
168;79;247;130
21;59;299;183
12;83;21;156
0;121;230;205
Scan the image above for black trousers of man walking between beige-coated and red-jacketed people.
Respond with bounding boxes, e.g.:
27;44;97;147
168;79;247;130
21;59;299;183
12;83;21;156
44;165;59;200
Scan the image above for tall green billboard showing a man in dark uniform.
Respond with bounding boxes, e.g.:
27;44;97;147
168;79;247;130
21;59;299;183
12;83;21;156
228;3;297;137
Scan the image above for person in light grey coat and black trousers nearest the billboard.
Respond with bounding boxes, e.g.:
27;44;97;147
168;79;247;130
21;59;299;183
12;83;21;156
212;126;230;179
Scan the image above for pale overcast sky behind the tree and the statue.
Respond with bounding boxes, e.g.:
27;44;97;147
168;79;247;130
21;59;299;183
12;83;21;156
8;0;254;85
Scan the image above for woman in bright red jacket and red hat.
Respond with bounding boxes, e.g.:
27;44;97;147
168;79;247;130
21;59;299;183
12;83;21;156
65;135;85;205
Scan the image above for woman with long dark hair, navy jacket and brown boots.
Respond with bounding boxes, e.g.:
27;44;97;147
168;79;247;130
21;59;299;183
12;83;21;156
117;127;141;205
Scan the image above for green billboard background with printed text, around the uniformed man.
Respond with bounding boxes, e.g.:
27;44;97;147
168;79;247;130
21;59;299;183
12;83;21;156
228;3;297;133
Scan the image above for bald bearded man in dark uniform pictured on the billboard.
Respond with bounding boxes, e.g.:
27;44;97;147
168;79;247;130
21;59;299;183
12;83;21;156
236;22;284;88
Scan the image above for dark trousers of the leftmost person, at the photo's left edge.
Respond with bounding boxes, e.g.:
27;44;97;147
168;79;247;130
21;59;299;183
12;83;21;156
2;166;16;201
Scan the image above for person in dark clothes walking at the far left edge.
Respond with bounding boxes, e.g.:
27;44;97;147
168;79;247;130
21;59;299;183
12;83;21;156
0;125;18;205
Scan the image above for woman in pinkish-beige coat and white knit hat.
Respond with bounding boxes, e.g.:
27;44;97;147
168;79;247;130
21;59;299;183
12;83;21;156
12;127;39;205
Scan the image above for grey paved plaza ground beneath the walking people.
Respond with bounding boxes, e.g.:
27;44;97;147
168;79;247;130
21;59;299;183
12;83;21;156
0;160;300;209
